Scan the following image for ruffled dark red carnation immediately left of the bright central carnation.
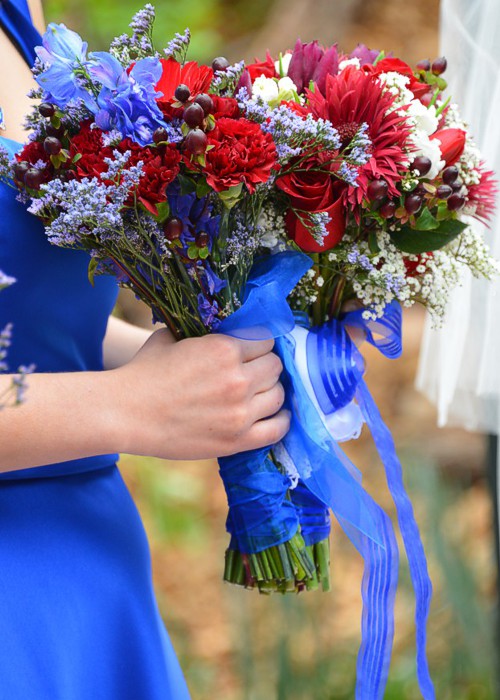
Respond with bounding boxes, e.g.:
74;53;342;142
118;139;181;214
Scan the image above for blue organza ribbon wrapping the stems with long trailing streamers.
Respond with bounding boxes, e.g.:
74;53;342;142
219;251;435;700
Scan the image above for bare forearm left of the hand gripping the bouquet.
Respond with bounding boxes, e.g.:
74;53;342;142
0;372;121;471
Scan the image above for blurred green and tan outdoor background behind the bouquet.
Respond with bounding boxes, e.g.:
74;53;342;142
45;0;500;700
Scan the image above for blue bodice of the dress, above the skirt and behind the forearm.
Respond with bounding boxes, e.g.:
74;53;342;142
0;137;117;478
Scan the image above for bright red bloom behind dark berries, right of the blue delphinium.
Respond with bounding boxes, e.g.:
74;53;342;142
156;58;214;117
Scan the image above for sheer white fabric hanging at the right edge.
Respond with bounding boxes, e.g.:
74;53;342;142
417;0;500;434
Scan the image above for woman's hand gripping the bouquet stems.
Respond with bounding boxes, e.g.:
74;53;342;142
110;330;289;459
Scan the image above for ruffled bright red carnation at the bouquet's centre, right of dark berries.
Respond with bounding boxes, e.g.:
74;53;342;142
203;117;277;193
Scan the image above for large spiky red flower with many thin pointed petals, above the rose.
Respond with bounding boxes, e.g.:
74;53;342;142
307;67;410;208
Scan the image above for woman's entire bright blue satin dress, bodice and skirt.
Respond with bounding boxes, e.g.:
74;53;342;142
0;0;189;700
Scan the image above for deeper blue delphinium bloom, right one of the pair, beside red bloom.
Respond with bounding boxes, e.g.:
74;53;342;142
89;51;166;146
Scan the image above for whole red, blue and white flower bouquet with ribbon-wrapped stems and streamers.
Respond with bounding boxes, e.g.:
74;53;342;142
3;5;499;700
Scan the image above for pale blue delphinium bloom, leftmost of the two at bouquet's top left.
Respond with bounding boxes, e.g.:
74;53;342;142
35;22;95;109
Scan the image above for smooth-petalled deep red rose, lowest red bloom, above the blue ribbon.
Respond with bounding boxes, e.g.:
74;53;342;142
276;159;346;253
